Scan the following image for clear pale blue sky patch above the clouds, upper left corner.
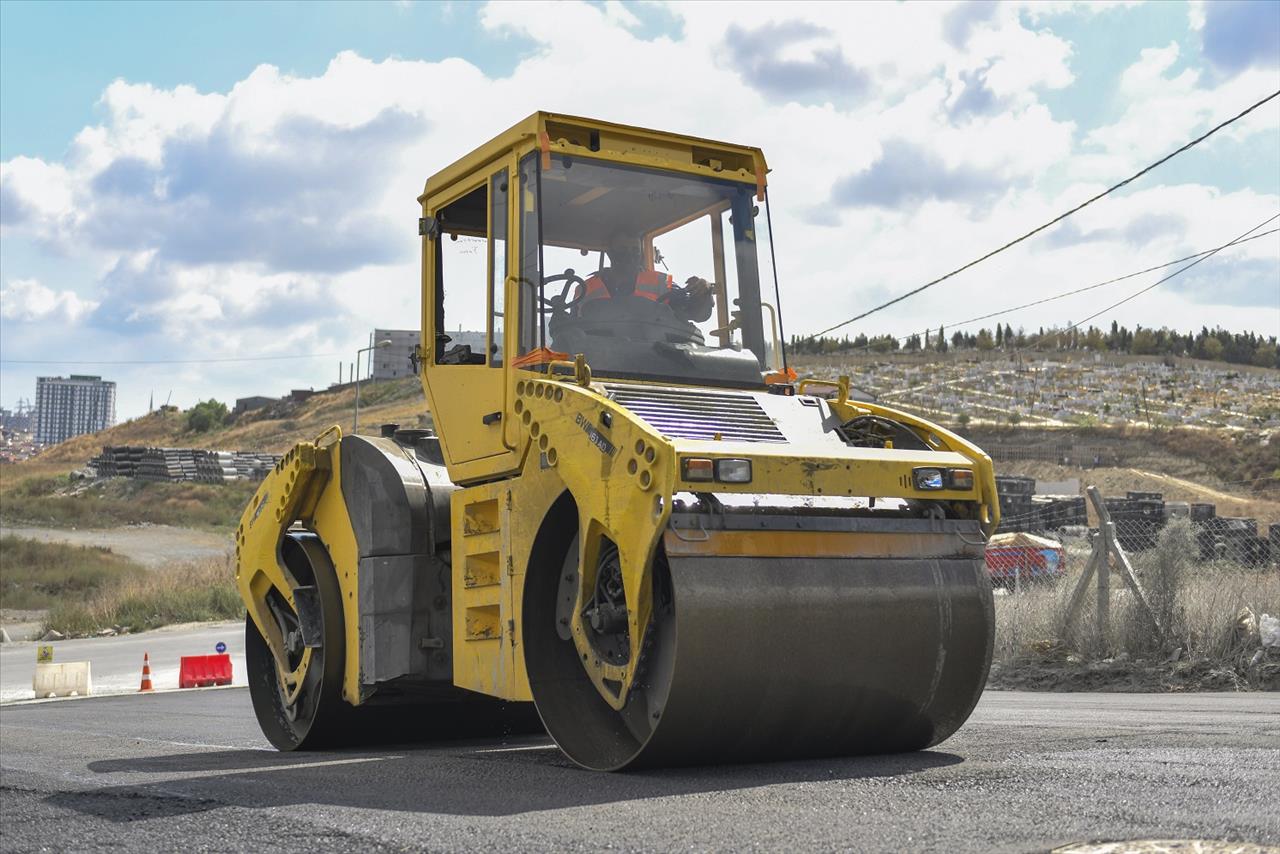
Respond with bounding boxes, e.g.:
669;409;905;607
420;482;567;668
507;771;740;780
0;0;531;160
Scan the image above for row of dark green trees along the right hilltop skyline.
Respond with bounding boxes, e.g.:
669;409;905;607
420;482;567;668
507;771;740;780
788;320;1280;367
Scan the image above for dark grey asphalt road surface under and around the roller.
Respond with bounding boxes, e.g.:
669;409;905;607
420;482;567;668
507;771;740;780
0;689;1280;851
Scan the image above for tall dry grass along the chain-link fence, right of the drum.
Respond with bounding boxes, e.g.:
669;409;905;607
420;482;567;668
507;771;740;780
995;524;1280;672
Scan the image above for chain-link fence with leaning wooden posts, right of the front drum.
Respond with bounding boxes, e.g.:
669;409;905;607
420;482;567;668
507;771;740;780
987;478;1280;673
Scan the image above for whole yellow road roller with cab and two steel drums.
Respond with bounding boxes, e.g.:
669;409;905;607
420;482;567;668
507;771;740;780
236;113;998;771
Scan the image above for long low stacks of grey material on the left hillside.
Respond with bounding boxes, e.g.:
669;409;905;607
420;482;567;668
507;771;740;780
88;446;280;483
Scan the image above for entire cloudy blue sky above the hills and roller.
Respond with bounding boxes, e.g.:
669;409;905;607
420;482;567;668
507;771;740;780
0;0;1280;419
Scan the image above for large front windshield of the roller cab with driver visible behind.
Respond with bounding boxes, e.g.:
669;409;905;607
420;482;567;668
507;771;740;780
520;154;774;385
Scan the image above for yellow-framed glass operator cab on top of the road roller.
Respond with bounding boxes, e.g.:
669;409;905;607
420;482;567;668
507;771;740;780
419;113;786;473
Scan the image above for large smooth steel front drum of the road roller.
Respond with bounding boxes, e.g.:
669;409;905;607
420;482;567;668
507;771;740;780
525;517;992;769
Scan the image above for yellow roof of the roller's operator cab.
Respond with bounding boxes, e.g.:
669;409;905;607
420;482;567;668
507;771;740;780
419;111;768;202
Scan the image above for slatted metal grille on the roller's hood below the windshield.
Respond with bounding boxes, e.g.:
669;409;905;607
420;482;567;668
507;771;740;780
605;385;787;443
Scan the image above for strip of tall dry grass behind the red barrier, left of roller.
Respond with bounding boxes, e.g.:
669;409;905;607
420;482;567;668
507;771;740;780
46;550;244;636
